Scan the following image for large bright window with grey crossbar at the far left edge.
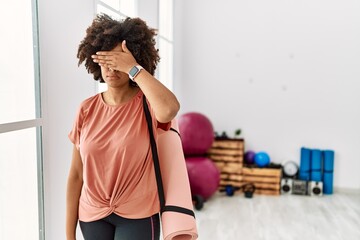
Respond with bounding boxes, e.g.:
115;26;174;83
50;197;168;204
0;0;45;240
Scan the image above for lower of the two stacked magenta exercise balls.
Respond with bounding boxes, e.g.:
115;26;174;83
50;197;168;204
185;157;220;200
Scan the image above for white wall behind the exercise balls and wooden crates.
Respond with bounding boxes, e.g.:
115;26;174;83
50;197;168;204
174;0;360;189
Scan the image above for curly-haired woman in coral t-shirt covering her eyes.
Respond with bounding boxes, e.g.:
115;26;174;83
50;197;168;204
66;15;179;240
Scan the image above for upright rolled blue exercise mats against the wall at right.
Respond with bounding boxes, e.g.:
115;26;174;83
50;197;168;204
299;147;334;194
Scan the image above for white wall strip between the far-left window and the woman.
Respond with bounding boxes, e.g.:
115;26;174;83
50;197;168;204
39;0;95;240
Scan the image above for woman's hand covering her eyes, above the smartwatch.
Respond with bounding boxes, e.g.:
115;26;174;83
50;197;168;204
91;40;137;73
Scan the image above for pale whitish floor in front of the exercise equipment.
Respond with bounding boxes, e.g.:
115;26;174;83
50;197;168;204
196;191;360;240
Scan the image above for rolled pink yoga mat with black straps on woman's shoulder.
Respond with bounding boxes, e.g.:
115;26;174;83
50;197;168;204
157;120;198;240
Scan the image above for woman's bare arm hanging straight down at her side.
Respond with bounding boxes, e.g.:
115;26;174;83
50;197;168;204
66;145;83;240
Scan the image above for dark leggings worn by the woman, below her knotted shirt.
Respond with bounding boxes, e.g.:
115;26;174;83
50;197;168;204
79;213;160;240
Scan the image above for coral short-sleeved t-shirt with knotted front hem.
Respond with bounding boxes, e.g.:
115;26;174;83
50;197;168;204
69;90;170;222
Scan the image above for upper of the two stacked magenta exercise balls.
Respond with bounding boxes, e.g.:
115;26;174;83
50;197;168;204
178;112;214;155
